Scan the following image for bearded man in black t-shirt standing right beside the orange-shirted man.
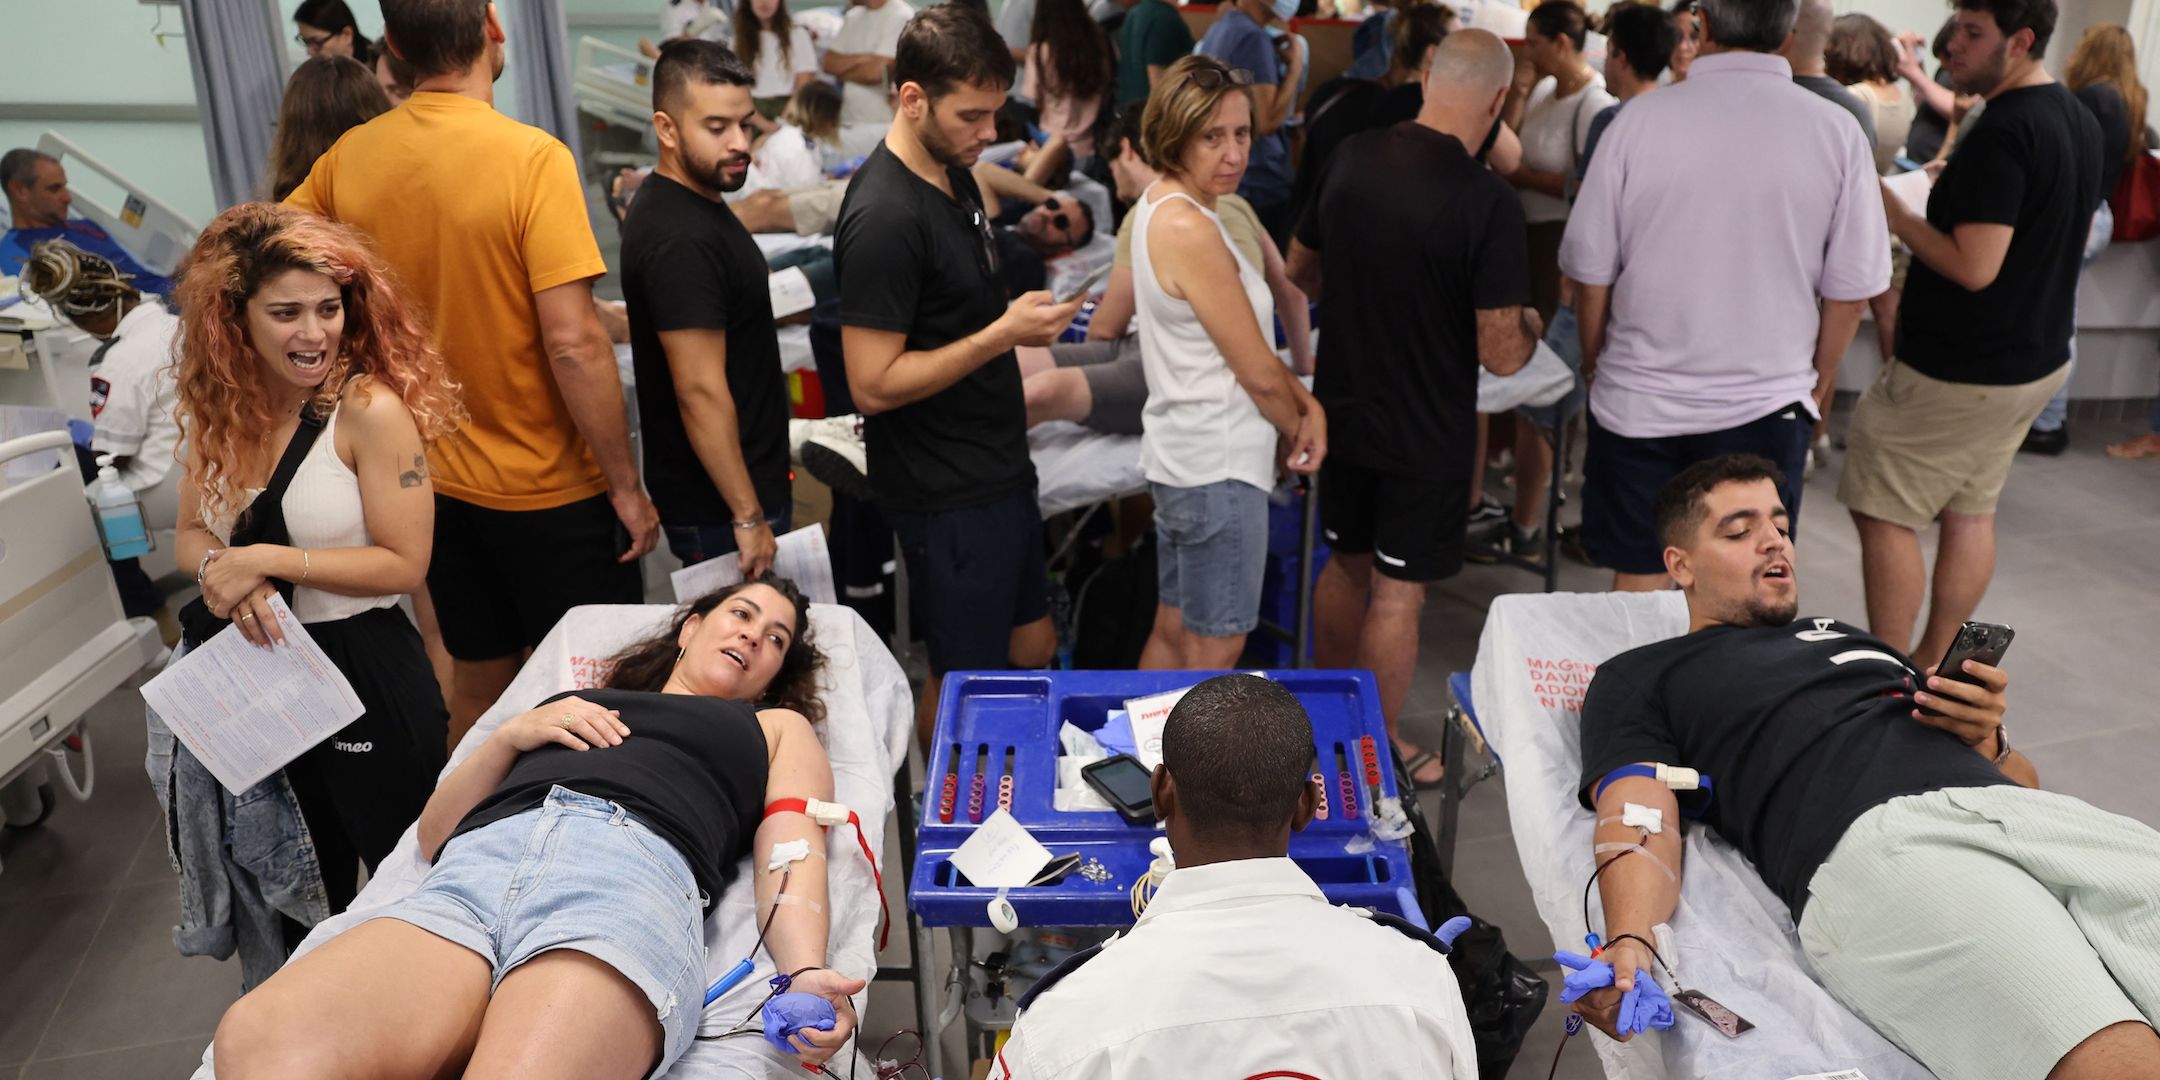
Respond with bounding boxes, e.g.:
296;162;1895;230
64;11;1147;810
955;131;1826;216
622;39;795;579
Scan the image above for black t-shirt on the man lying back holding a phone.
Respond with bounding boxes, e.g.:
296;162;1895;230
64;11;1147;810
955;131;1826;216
1579;618;2009;922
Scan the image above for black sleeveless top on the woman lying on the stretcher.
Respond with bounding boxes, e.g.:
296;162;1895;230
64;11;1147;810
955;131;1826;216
445;689;767;914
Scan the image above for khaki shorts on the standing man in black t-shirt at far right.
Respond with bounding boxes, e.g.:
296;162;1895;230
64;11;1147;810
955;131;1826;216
1838;361;2069;529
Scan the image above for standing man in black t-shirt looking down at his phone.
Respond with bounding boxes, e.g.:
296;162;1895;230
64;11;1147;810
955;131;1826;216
834;4;1080;741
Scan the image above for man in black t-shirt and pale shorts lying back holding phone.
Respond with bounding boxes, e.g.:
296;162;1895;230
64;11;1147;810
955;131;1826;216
1575;456;2160;1080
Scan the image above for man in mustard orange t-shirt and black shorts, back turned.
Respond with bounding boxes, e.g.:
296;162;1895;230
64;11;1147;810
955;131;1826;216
287;0;659;743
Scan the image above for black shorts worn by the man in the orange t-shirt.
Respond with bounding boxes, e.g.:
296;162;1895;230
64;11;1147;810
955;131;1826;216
428;495;646;661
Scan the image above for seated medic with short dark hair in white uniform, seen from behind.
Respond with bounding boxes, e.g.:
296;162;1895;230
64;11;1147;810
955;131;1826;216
989;674;1477;1080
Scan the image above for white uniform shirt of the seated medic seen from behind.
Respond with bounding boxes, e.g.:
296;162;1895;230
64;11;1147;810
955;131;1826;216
989;858;1477;1080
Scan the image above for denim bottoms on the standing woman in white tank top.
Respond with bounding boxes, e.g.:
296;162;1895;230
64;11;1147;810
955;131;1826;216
1149;480;1268;637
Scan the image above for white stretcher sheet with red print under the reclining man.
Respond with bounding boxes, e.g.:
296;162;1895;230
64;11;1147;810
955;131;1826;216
1471;592;1929;1080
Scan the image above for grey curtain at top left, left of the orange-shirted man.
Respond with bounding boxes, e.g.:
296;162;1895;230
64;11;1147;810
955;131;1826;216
179;0;285;210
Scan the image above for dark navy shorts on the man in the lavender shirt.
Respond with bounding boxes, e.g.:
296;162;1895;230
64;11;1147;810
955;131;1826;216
1583;404;1814;575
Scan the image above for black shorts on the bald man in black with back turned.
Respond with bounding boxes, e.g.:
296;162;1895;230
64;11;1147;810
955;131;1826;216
1320;454;1471;581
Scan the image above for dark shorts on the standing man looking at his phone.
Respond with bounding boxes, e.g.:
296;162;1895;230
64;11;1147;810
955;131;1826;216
886;484;1050;676
